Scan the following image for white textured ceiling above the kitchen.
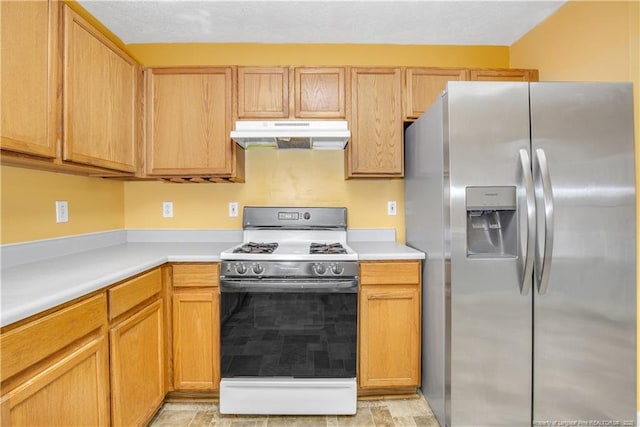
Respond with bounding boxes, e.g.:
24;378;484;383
78;0;565;46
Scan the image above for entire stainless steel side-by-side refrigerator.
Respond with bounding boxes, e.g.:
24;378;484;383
405;82;636;427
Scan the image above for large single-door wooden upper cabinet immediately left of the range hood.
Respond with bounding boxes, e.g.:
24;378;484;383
145;67;244;180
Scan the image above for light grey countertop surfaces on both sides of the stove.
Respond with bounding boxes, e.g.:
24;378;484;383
0;237;425;326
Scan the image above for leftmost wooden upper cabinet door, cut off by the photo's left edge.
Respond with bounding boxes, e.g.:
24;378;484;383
0;0;59;158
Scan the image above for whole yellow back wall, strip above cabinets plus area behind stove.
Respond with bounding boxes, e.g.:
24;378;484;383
125;44;509;242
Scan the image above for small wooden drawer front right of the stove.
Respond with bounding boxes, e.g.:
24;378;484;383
360;261;420;285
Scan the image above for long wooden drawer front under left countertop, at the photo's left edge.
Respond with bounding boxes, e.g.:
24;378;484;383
0;293;107;381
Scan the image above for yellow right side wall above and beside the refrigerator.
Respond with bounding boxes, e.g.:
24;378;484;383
510;1;640;411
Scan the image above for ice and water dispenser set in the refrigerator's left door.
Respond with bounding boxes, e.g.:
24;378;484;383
466;187;518;258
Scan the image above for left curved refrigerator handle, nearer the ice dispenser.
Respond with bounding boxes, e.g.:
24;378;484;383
518;149;536;296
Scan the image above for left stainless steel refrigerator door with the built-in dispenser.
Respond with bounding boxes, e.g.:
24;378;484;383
444;82;532;427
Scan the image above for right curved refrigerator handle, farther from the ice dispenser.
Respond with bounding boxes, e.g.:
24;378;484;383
534;148;554;295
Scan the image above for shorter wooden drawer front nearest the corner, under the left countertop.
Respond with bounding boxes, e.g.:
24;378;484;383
107;268;162;320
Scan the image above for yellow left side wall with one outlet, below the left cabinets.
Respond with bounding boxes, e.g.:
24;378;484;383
0;166;124;243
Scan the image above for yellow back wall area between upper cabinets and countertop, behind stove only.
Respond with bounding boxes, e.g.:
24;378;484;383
125;149;404;240
